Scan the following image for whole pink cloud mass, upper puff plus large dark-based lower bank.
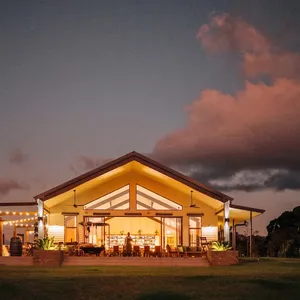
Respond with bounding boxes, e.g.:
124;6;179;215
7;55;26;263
153;14;300;191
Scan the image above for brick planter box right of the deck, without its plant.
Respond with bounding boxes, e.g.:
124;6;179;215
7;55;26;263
207;250;239;266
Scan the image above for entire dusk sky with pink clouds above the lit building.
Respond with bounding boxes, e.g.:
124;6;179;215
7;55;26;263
0;0;300;233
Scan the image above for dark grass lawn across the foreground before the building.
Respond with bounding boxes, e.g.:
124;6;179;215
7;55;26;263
0;259;300;300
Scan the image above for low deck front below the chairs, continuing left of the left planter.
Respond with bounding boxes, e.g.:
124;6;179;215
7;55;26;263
0;256;210;267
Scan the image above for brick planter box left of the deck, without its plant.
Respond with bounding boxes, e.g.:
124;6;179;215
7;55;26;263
33;250;64;267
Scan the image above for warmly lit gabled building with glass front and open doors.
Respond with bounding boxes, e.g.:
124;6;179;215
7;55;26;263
34;152;264;248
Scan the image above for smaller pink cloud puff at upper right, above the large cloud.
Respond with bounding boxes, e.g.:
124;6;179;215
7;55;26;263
197;14;300;78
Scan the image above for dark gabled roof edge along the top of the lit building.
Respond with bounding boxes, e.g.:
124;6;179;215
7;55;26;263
34;151;233;202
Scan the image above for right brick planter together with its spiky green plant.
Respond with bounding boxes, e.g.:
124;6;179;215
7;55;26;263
207;242;239;266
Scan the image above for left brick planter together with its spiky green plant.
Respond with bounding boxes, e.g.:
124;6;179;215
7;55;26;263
33;237;63;266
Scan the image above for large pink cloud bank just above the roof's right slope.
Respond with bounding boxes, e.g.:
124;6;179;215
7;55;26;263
154;79;300;168
